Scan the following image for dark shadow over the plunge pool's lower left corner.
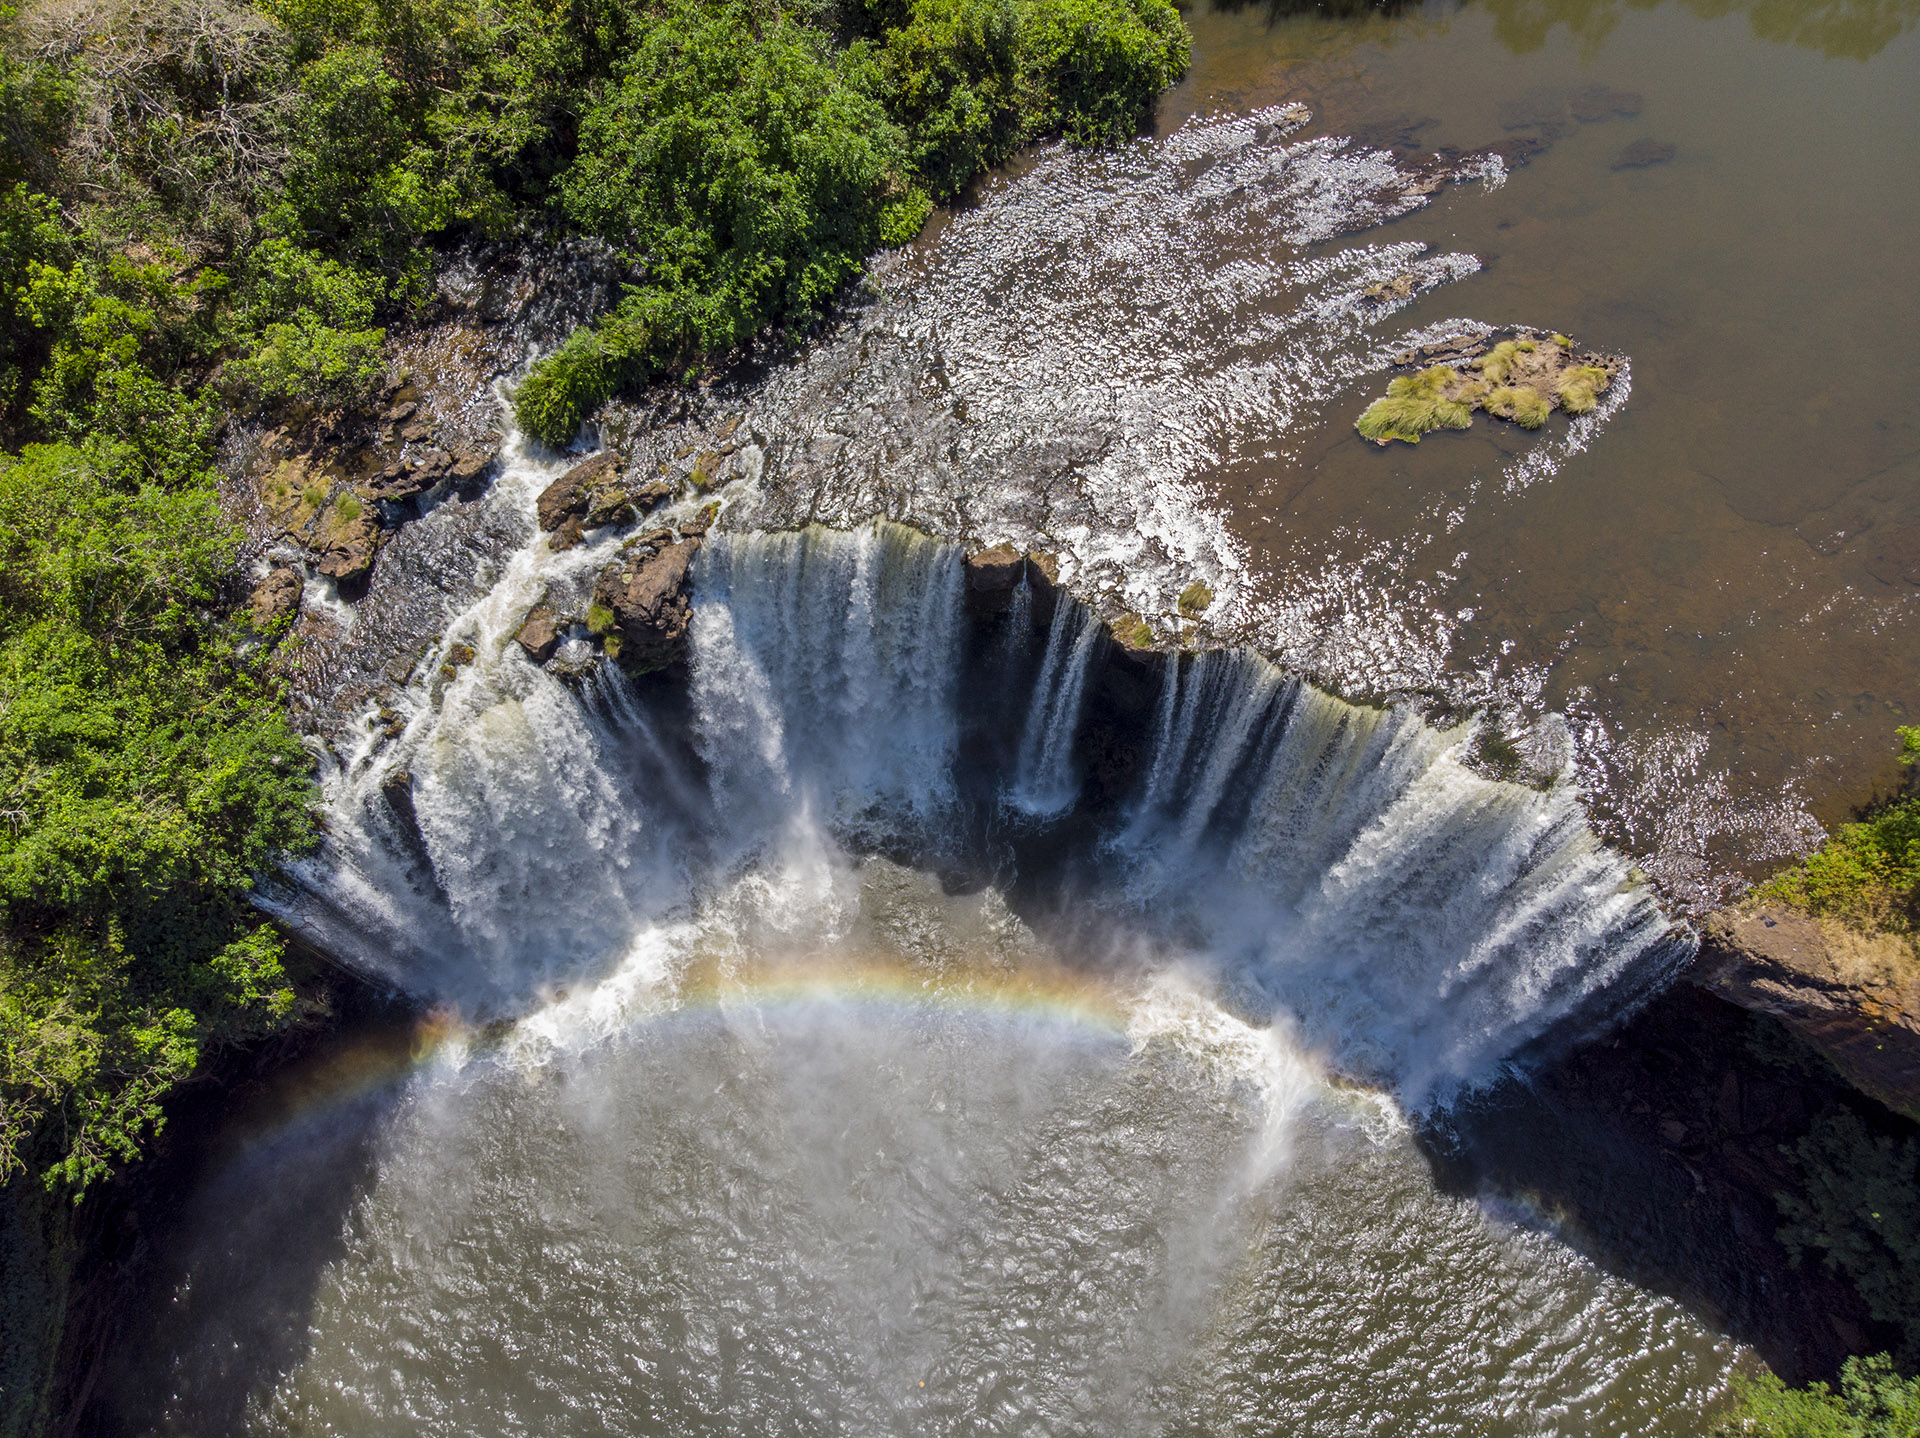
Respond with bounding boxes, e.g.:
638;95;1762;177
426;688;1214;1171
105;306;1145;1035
77;991;417;1438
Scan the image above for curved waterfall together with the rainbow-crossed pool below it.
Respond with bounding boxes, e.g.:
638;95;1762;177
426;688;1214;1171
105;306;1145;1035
149;397;1736;1434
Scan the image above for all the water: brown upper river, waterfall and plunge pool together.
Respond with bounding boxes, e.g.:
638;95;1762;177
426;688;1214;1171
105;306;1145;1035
102;4;1920;1436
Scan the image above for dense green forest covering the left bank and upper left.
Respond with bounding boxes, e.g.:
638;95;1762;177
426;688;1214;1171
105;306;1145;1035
0;0;1187;1194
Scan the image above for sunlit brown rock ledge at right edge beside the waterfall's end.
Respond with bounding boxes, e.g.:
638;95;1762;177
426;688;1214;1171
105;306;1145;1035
1688;904;1920;1119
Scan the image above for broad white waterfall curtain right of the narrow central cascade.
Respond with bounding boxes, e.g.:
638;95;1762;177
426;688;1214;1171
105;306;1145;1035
1116;653;1686;1106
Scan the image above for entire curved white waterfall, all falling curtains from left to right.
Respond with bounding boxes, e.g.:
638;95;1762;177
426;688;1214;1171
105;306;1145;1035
267;495;1680;1104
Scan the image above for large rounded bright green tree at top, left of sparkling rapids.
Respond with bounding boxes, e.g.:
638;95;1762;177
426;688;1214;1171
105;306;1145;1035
561;0;906;408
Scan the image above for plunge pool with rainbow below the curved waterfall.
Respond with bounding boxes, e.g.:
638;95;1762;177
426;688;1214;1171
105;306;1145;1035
129;856;1738;1434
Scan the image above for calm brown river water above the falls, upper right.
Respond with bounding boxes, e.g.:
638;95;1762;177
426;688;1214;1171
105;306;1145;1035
1162;0;1920;900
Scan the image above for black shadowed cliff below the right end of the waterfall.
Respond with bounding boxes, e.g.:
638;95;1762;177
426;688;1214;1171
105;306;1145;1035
1421;981;1912;1382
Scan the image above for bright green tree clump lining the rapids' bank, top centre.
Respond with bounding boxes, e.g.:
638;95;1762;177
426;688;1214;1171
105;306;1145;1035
516;0;1188;443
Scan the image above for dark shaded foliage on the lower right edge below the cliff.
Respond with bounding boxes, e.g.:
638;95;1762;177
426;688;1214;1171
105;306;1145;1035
1778;1110;1920;1359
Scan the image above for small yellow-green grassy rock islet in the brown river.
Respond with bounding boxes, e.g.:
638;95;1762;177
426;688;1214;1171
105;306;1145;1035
1354;334;1619;445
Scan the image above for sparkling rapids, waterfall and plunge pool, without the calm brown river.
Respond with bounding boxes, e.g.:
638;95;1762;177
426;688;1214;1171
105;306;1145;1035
115;83;1812;1438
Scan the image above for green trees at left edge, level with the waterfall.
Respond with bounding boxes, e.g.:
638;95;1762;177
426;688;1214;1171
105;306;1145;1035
0;443;309;1188
